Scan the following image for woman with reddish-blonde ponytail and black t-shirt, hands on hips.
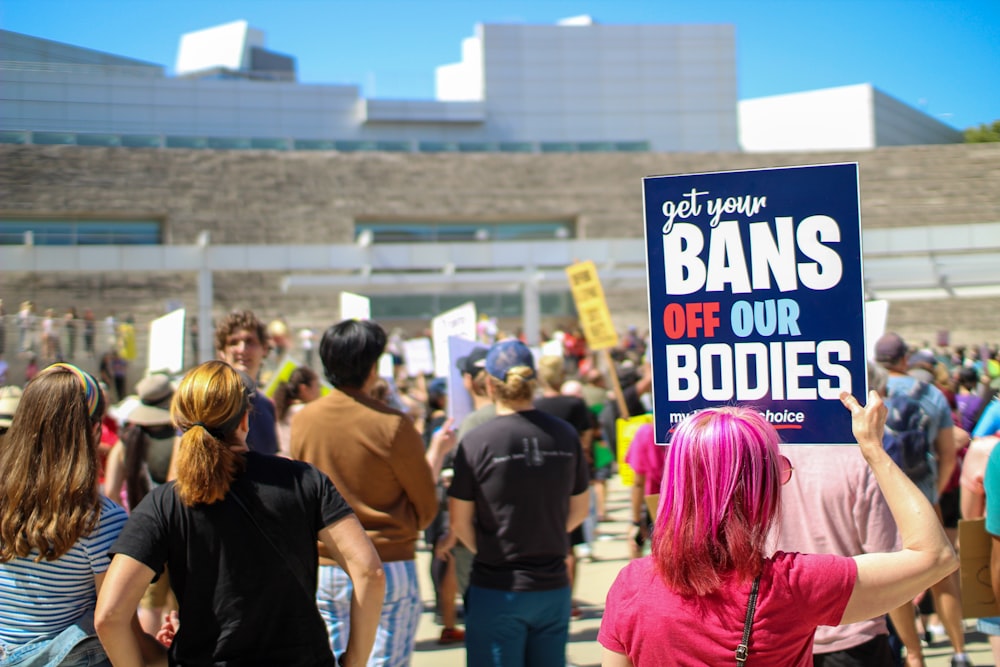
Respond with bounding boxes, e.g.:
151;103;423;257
96;361;385;666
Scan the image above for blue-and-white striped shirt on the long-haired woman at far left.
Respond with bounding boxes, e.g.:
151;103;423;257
0;496;127;646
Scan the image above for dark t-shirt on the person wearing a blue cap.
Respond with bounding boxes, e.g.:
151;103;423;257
448;410;588;591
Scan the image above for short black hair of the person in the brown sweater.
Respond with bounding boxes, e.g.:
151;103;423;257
319;320;387;389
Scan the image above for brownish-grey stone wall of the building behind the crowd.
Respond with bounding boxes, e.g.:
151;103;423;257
0;144;1000;378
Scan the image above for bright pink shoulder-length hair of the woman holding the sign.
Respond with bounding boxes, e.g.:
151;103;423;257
653;407;781;595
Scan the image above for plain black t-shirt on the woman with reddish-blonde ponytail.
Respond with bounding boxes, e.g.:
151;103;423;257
111;452;352;666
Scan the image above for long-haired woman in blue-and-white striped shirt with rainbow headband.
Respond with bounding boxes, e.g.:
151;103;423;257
0;363;160;667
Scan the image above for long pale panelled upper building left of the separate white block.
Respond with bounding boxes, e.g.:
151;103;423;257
0;17;738;152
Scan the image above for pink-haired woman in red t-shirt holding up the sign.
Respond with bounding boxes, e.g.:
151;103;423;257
598;392;958;667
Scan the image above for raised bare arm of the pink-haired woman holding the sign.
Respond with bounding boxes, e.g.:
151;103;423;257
840;391;958;624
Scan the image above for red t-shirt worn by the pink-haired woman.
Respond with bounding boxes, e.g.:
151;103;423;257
597;552;857;667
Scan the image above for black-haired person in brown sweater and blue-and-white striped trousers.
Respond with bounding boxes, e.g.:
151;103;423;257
291;320;455;667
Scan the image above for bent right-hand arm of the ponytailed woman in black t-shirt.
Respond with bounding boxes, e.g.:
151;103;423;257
319;514;385;667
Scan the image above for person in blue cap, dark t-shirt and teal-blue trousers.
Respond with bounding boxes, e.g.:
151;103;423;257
448;339;589;665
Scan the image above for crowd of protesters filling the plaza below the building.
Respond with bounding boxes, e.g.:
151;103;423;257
0;309;1000;667
